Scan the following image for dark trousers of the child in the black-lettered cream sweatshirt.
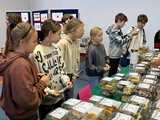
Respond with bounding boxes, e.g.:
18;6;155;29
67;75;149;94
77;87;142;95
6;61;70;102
39;99;64;120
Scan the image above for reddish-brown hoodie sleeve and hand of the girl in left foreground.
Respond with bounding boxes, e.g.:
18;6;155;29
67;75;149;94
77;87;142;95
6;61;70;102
11;63;47;110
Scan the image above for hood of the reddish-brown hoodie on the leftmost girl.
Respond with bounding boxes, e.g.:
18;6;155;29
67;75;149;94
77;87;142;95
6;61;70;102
0;53;22;74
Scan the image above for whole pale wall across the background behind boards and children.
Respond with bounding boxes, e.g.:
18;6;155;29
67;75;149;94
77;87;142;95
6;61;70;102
0;0;160;48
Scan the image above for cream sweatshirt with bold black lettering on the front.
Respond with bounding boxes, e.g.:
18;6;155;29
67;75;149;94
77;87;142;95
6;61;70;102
34;46;64;90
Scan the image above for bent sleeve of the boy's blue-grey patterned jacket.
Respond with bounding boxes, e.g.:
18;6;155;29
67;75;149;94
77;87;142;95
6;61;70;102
110;31;132;46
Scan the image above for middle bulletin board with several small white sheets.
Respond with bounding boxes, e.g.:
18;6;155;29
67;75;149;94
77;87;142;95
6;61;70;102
32;10;48;41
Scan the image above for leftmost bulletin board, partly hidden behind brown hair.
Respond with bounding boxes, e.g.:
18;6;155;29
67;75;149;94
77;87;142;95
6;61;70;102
6;11;31;23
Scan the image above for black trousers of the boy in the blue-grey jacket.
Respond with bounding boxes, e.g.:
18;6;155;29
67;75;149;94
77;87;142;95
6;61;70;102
108;58;120;77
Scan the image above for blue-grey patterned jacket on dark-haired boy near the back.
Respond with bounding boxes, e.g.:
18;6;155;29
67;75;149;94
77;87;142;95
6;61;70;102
106;25;132;59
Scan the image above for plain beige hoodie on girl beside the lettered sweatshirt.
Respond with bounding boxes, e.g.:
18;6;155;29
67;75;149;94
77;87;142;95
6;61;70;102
58;35;80;78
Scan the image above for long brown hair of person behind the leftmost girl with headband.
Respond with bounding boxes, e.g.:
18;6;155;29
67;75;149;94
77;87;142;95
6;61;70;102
4;14;22;54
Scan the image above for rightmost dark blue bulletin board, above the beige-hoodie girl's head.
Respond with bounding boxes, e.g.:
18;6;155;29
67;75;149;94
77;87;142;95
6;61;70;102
50;9;79;22
